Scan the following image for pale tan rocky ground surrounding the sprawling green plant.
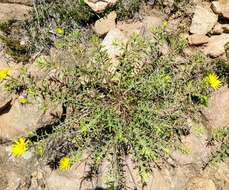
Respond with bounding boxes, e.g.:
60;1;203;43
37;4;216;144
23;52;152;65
0;0;229;190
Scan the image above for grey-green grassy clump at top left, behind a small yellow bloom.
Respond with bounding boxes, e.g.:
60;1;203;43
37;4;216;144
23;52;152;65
22;0;98;51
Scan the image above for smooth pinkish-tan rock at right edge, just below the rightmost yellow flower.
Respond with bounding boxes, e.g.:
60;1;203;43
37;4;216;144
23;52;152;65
203;86;229;129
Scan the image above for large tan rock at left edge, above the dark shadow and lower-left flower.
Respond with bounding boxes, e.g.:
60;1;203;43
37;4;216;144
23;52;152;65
0;98;62;139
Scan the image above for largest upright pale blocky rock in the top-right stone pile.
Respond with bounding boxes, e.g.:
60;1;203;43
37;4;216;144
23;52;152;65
190;6;218;34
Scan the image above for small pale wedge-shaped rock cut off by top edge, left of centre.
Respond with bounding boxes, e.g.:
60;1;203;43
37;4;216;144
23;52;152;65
84;0;118;13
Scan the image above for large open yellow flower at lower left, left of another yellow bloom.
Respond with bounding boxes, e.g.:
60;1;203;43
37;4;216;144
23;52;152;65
11;137;29;157
